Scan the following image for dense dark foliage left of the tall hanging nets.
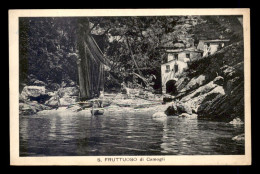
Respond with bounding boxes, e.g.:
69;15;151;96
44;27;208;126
19;18;77;87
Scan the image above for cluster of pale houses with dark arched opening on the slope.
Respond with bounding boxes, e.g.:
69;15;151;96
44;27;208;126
161;40;229;94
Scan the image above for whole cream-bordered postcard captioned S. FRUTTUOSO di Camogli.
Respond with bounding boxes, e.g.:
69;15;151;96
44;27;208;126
9;9;251;165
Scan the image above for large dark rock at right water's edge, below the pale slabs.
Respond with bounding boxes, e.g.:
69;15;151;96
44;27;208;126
198;77;244;122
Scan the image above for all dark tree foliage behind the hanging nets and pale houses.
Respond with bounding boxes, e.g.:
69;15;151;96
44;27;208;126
19;16;243;91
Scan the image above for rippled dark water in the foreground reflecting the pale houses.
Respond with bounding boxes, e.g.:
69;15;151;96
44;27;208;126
20;112;244;156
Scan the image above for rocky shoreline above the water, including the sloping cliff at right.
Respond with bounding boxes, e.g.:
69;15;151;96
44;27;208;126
19;42;244;124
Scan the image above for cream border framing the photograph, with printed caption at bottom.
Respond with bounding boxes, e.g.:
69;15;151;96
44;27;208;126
9;9;251;165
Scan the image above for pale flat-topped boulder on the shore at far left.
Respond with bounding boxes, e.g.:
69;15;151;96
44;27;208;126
21;86;45;100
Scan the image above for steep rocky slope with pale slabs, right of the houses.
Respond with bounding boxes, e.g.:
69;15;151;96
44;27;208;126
176;42;244;121
